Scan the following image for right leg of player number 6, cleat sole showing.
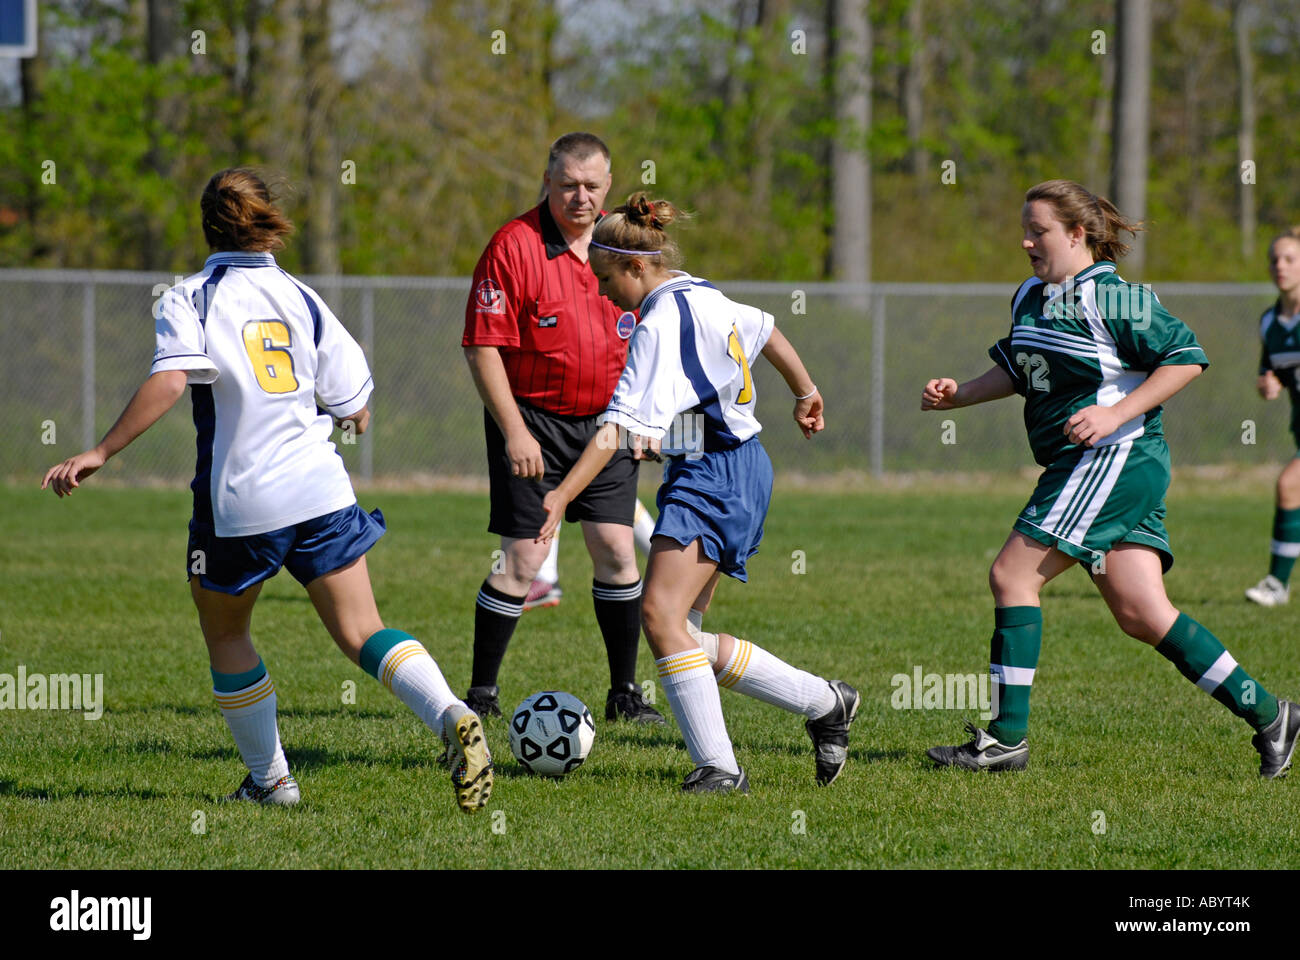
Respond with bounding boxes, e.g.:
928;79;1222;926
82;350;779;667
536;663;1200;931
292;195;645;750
307;555;493;810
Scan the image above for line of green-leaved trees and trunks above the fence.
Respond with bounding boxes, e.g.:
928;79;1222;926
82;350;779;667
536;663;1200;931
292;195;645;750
0;0;1300;282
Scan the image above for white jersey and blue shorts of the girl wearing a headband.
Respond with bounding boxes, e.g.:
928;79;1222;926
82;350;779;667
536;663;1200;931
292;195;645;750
597;272;774;580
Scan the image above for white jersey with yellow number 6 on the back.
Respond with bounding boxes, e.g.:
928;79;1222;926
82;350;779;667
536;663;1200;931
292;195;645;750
151;252;373;537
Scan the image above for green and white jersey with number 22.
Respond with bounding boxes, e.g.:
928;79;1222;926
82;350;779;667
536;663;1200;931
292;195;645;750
988;260;1211;467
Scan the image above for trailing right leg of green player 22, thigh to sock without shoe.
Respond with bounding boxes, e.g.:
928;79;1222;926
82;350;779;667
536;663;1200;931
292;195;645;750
1093;544;1278;731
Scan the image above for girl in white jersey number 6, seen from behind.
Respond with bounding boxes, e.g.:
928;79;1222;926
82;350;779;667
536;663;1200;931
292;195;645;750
42;169;493;810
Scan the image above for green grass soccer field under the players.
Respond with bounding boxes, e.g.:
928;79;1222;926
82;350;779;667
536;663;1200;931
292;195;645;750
0;477;1300;869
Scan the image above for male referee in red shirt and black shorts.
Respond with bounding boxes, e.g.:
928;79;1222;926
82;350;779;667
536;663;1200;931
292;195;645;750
460;133;664;723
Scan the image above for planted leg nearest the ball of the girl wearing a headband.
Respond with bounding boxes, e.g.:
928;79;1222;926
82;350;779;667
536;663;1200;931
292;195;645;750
641;536;744;790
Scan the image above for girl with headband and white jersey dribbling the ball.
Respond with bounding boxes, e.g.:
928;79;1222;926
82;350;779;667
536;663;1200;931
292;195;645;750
538;194;861;792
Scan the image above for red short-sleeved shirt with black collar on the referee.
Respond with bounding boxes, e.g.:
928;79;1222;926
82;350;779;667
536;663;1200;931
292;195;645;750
460;200;634;416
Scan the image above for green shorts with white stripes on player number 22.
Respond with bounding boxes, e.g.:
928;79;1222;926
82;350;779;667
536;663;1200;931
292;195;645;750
1014;437;1174;572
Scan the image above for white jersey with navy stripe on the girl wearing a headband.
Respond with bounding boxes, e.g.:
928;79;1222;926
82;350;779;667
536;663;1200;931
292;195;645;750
597;271;774;455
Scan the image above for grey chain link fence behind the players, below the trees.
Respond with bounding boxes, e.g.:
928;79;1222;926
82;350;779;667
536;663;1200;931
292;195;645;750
0;269;1279;487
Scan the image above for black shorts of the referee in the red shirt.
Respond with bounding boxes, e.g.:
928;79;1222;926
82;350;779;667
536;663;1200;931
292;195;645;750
484;401;640;540
